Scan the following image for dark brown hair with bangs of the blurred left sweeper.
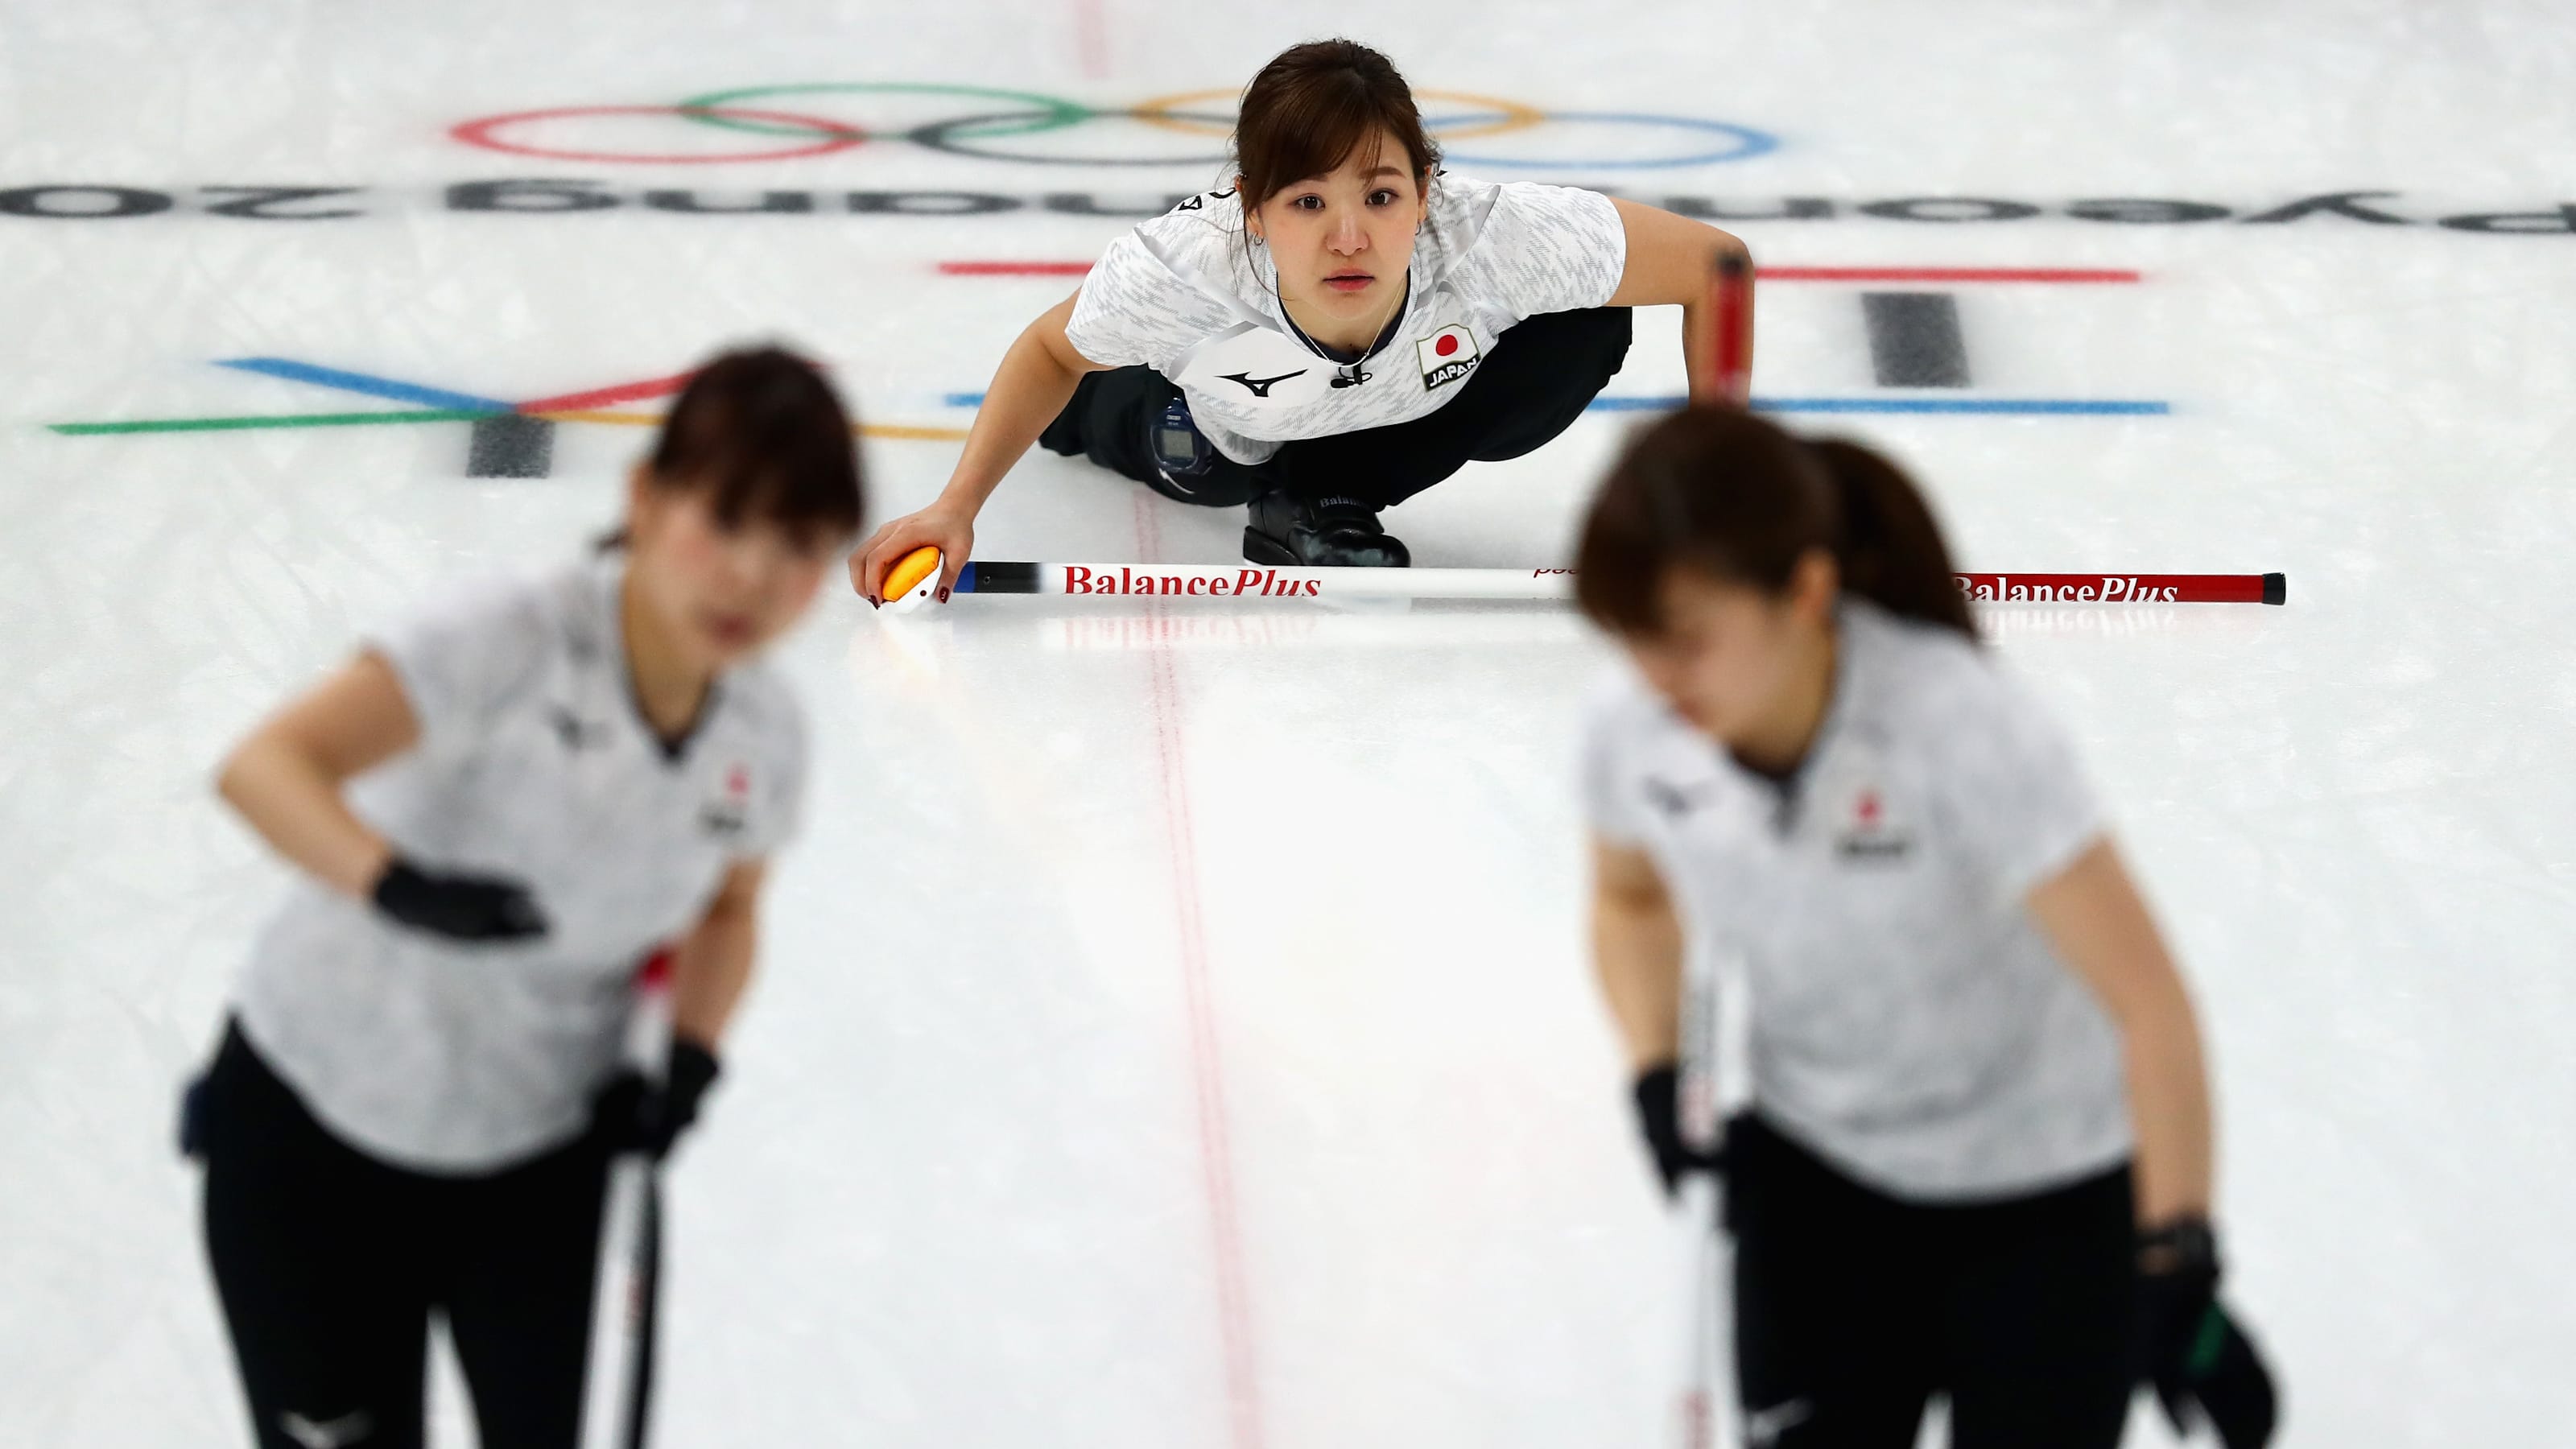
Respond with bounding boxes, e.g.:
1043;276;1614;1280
631;348;868;539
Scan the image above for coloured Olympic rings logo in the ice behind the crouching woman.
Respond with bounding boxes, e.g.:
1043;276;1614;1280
448;80;1780;170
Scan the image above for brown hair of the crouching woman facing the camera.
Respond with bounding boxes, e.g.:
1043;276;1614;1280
1234;41;1440;212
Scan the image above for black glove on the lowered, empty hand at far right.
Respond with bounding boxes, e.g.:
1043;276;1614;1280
2138;1220;2280;1449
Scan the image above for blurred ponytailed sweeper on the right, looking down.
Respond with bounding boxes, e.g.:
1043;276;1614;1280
1576;407;2275;1449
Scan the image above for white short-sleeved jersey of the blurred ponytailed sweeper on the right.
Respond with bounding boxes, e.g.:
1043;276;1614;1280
1584;601;2130;1202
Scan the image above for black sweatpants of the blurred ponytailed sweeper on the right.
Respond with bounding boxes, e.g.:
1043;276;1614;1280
1726;1117;2136;1449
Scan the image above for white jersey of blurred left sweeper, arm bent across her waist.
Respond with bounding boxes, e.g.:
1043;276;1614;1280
237;555;807;1170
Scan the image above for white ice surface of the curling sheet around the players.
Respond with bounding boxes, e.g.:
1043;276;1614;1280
0;0;2576;1449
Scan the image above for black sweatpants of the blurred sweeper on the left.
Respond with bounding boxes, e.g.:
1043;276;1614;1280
198;1026;628;1449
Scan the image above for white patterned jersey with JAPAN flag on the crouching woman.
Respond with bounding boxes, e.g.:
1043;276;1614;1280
1064;173;1628;464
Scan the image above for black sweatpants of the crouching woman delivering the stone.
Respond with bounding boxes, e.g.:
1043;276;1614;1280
1038;307;1631;508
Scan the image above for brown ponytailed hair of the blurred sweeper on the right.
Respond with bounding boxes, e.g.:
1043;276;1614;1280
1574;405;1975;639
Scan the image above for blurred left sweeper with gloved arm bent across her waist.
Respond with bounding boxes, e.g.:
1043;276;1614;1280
180;351;861;1449
